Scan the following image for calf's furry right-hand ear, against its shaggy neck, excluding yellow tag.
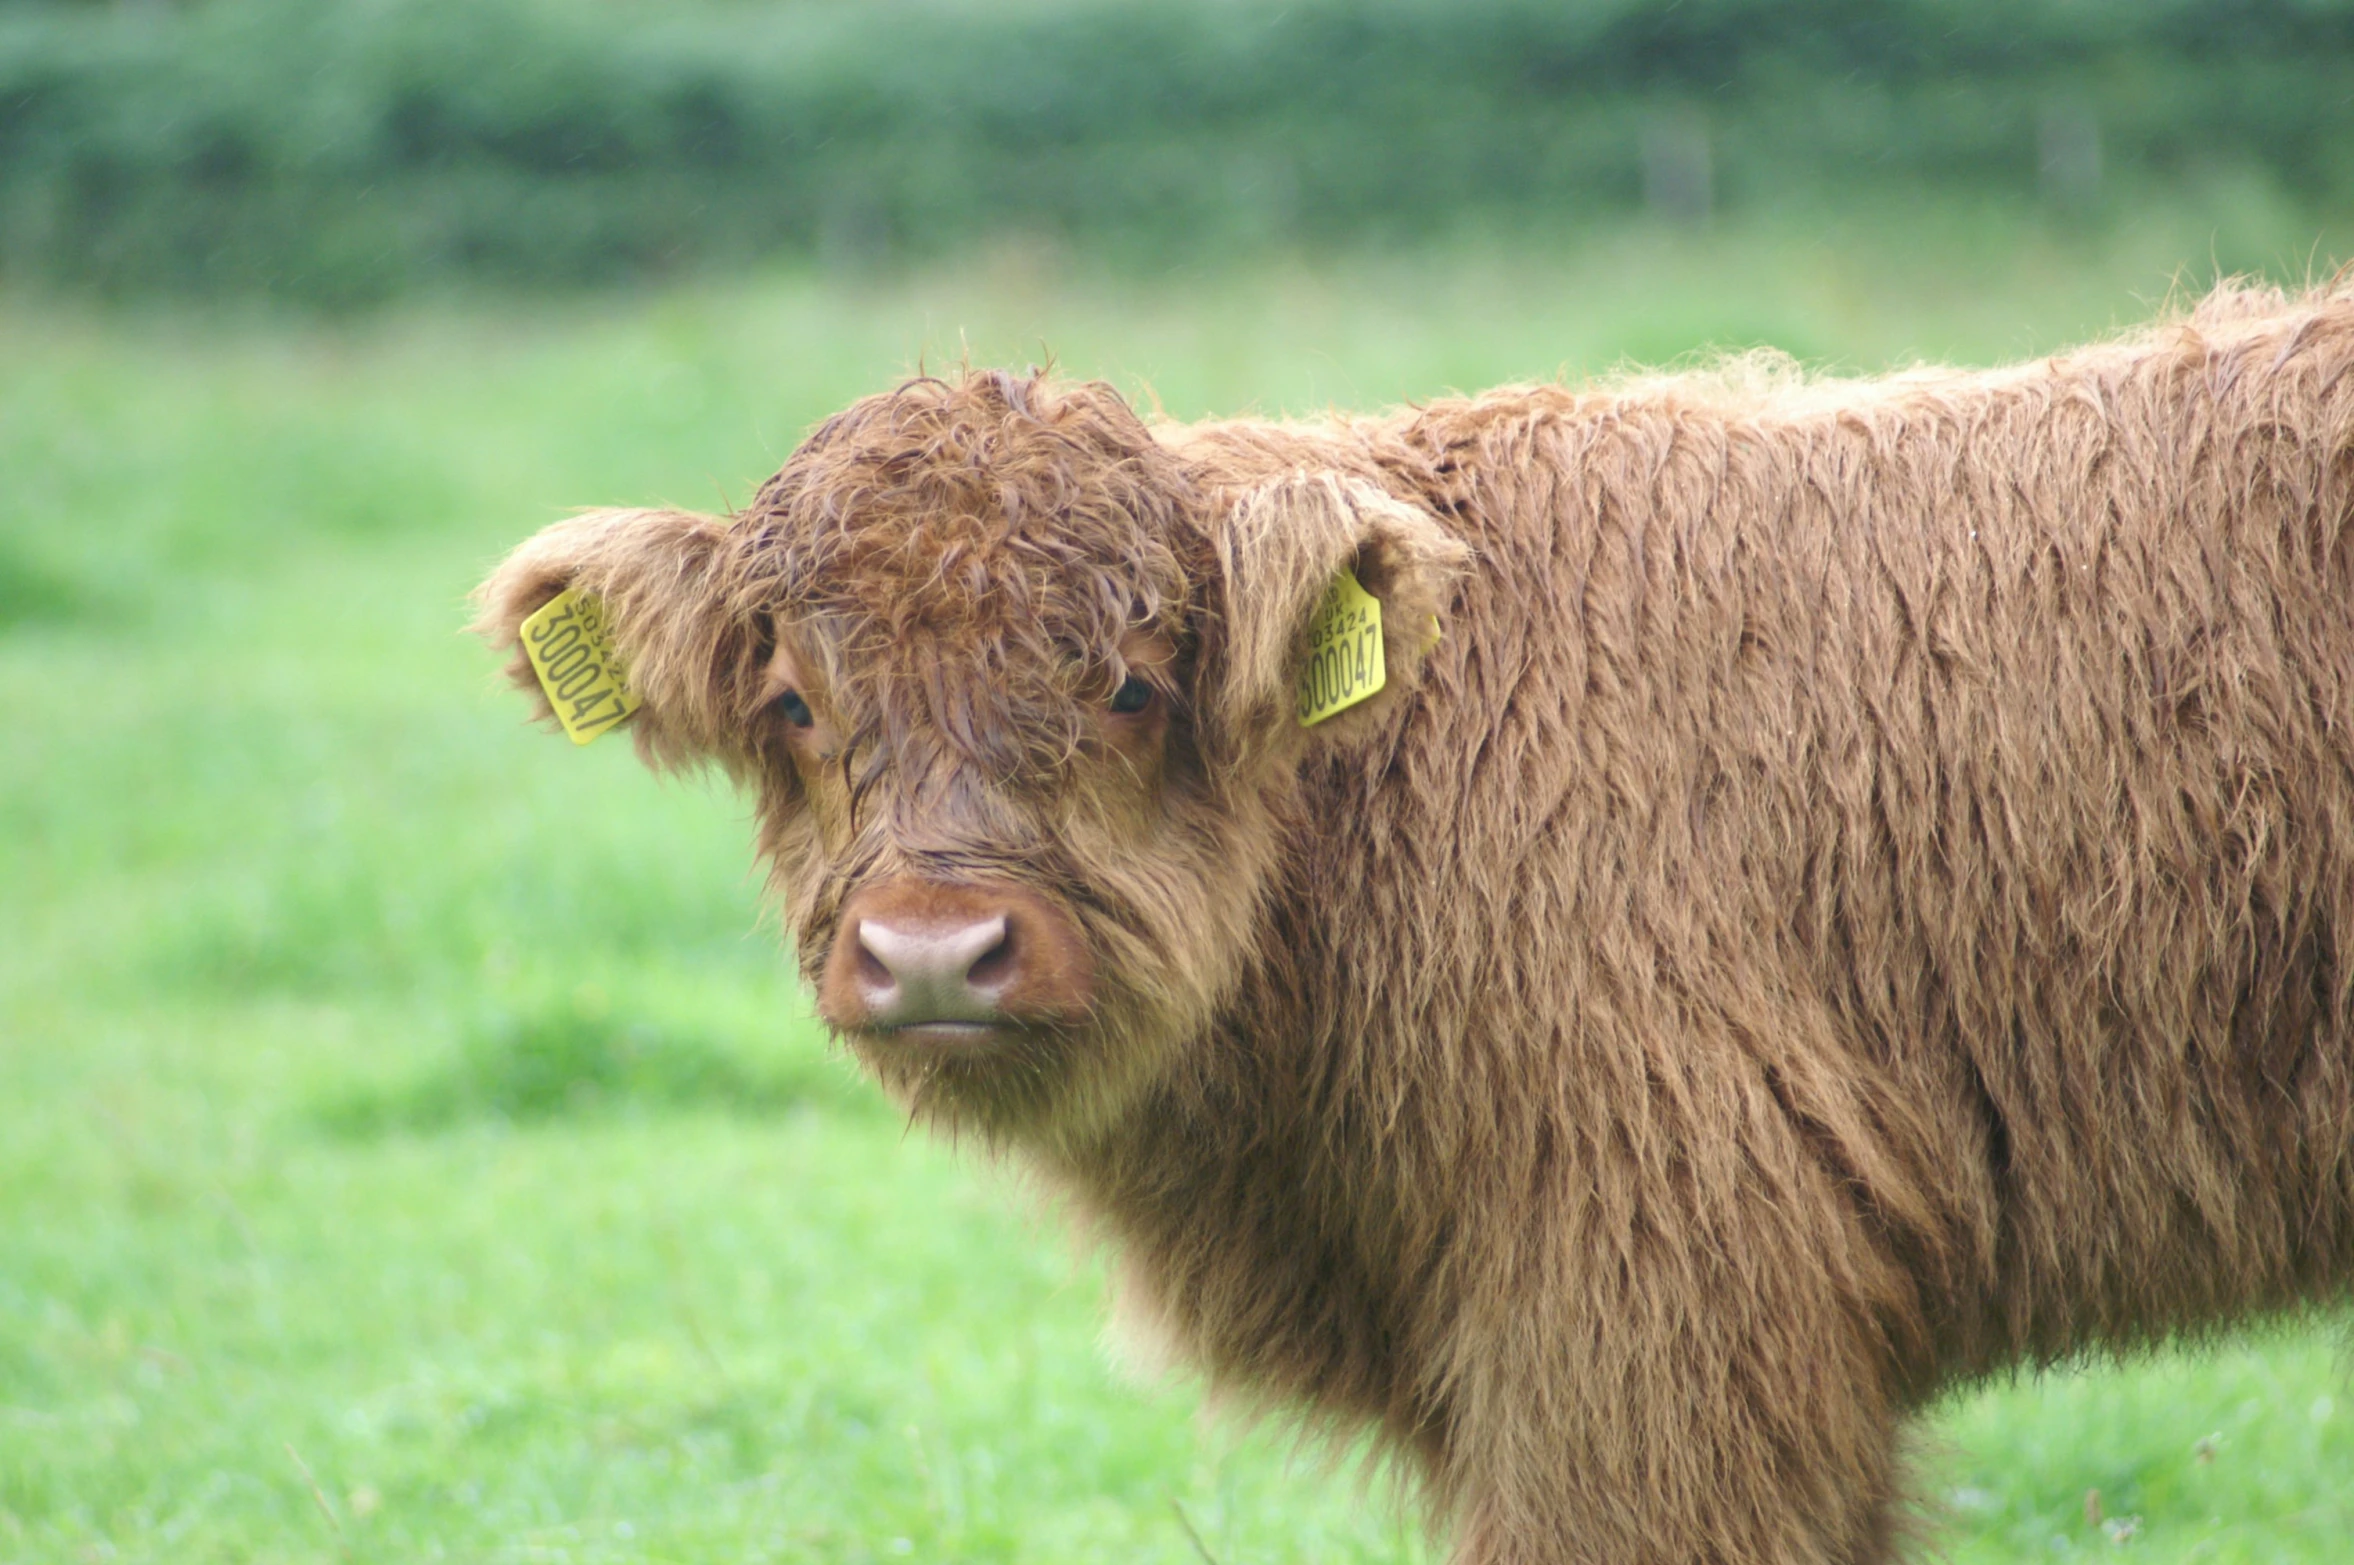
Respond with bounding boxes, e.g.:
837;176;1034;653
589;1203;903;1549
1201;473;1471;755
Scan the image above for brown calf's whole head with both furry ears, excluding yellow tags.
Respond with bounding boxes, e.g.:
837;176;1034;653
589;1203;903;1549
483;374;1462;1137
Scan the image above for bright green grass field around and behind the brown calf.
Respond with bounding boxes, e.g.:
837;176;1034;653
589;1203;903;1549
13;207;2354;1565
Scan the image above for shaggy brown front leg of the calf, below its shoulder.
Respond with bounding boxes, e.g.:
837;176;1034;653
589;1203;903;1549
1438;1163;1904;1565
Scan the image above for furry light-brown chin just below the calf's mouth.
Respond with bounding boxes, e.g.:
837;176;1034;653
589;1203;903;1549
838;1021;1186;1146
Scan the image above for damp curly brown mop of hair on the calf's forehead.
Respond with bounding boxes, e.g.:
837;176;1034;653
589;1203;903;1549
737;369;1210;770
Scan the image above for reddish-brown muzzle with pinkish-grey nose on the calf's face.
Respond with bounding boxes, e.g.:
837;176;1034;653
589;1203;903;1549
817;875;1095;1043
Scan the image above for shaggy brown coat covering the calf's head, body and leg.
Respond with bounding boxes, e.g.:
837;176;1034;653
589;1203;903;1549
483;287;2354;1565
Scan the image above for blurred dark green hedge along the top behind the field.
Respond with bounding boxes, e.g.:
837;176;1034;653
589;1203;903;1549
0;0;2354;301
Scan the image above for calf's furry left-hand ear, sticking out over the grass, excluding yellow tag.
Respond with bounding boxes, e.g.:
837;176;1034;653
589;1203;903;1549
473;511;760;767
